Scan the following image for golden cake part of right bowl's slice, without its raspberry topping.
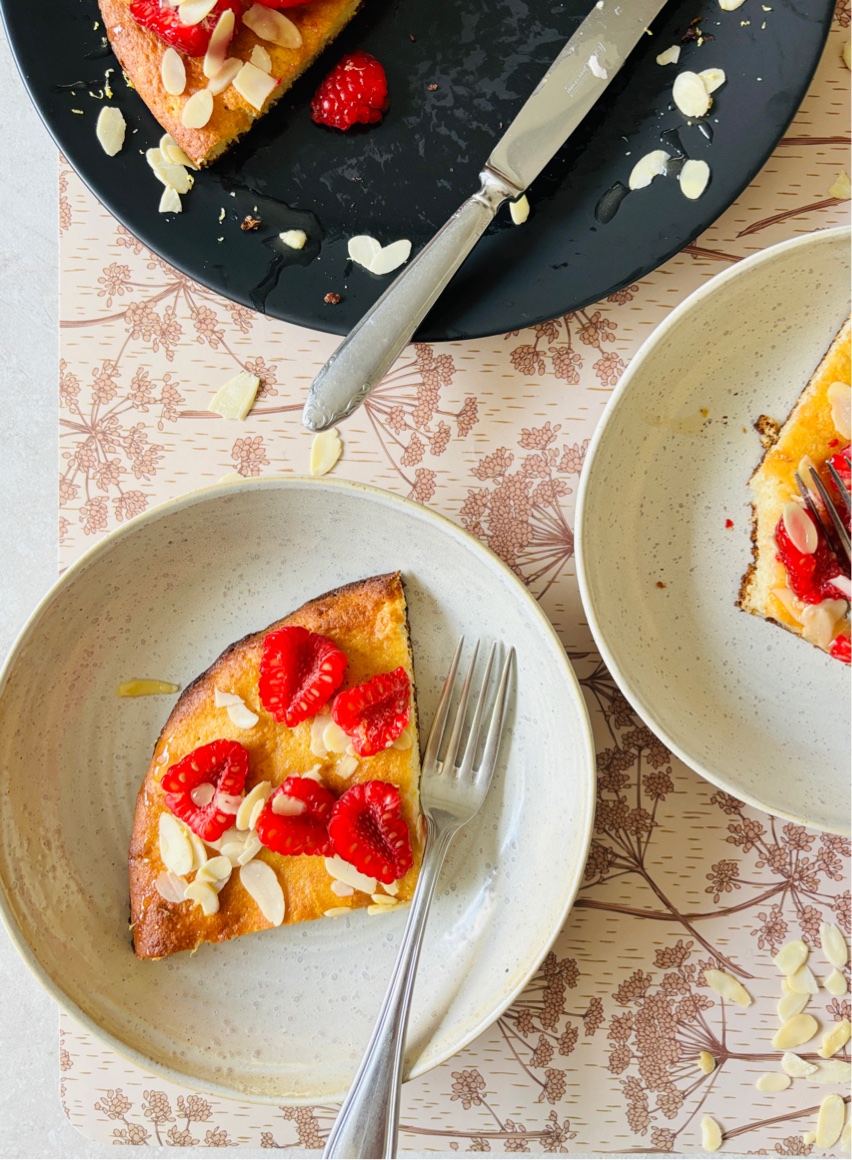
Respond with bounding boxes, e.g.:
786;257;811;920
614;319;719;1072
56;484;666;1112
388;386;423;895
737;319;852;636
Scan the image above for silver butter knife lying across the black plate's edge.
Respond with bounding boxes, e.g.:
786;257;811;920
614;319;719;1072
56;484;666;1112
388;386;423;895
302;0;666;432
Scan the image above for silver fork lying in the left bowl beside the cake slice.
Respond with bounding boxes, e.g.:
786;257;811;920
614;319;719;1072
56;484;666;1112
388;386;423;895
323;638;514;1160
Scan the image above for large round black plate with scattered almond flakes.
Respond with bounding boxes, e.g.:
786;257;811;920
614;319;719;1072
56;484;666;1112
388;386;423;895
0;0;833;341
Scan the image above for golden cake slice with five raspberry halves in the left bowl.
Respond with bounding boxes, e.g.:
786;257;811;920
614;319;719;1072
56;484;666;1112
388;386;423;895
129;573;423;958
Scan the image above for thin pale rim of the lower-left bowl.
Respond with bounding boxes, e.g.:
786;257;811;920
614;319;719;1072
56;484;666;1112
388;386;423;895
0;473;597;1107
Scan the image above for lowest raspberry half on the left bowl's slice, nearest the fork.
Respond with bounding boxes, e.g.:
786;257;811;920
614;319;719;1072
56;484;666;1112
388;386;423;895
328;782;413;885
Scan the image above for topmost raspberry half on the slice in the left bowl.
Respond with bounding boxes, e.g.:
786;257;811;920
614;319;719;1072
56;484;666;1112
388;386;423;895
258;625;347;728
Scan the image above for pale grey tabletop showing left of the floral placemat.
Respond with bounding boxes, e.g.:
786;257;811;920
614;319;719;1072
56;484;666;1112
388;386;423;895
0;27;293;1160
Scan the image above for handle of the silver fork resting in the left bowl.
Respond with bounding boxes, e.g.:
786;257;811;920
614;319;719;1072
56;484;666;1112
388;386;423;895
323;819;456;1160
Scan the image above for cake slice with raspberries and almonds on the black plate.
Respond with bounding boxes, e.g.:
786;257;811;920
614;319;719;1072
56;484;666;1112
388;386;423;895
99;0;361;166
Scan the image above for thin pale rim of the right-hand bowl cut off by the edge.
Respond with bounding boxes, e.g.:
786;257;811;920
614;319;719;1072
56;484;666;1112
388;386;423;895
575;225;852;836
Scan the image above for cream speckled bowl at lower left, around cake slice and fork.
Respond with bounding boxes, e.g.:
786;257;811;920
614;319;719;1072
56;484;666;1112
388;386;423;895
0;478;594;1103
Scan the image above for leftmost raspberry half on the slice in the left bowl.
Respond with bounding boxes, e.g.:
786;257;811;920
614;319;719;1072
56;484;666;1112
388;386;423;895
163;740;248;842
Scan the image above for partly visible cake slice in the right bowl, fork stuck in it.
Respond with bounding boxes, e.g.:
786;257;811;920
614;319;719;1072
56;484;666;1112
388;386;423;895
737;321;850;664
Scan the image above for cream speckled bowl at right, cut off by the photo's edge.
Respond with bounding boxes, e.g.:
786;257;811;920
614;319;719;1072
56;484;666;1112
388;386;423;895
577;229;850;833
